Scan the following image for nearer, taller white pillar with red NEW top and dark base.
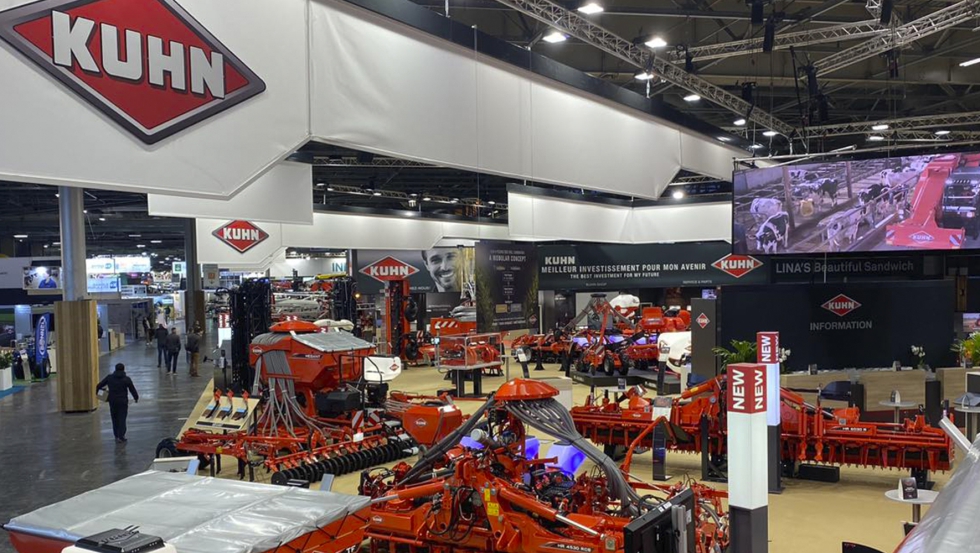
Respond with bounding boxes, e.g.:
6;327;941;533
727;363;771;553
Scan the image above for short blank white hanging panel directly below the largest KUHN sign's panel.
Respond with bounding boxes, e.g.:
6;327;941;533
147;161;313;225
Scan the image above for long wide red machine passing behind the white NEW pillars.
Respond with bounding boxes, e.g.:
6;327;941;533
572;375;953;477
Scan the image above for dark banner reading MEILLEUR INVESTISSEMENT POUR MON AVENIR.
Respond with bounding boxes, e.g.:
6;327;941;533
538;242;769;290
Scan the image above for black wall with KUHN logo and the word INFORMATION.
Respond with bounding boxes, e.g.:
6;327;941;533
720;281;955;371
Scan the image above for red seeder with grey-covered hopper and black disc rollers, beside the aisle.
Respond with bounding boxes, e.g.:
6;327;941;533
157;321;458;484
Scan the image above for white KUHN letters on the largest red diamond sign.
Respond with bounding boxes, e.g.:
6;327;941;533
51;11;225;98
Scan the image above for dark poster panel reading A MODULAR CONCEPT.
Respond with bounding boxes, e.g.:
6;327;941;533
476;242;538;332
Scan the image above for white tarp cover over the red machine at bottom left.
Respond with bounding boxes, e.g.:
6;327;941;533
6;471;370;553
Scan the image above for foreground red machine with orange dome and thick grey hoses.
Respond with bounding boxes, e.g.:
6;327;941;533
360;379;728;553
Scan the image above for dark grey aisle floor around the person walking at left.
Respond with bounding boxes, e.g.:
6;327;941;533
0;333;213;553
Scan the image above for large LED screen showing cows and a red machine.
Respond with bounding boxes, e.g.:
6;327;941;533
733;153;980;254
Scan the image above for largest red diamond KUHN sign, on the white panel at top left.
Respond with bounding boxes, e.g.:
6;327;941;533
0;0;265;144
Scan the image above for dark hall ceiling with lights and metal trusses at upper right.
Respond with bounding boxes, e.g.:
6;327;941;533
412;0;980;154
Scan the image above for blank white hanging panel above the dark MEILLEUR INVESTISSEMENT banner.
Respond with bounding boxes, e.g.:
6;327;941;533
507;192;732;244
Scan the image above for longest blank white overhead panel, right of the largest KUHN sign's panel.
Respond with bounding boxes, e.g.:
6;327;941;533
311;0;717;198
